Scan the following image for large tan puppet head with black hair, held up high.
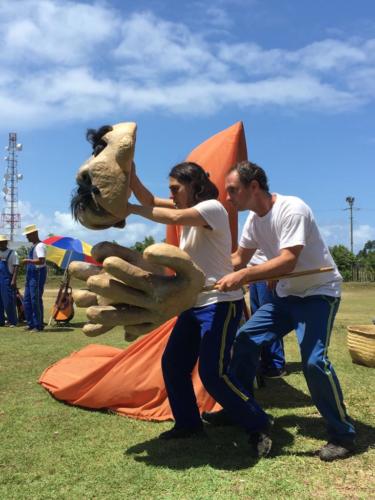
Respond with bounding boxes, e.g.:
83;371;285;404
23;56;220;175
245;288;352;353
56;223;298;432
71;122;137;229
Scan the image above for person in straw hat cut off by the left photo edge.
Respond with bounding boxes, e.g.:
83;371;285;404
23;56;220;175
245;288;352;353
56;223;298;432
0;234;19;328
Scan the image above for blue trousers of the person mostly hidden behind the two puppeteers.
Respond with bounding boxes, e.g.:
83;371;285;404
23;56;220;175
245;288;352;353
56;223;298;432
249;281;285;373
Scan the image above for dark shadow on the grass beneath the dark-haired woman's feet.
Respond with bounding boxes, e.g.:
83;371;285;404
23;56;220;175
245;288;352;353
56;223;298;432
124;425;294;471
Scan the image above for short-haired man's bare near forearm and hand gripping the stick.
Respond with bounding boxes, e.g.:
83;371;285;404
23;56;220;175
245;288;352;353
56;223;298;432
215;245;303;292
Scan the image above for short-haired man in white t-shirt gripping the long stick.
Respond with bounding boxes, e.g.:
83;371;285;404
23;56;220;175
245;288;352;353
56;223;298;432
216;162;355;461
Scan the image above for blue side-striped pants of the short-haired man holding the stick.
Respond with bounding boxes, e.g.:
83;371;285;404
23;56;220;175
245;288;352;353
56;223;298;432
230;295;355;439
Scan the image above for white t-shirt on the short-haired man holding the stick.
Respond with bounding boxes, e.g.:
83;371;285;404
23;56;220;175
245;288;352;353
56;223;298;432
240;194;342;297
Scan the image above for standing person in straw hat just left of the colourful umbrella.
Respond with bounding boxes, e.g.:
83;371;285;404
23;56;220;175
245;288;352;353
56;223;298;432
22;224;47;332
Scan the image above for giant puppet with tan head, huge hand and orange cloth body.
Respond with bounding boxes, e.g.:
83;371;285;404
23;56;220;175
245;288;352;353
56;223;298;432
39;122;247;420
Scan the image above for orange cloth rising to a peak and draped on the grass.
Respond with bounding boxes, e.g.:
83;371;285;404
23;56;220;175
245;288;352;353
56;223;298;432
39;122;247;420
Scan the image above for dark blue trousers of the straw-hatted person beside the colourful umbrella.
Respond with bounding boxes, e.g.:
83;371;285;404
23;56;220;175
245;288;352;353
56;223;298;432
23;264;47;330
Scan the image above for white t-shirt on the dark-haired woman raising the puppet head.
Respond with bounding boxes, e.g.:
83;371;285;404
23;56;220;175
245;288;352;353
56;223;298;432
180;200;243;307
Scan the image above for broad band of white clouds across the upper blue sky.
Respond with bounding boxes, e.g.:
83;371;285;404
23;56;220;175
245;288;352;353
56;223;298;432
0;0;375;129
